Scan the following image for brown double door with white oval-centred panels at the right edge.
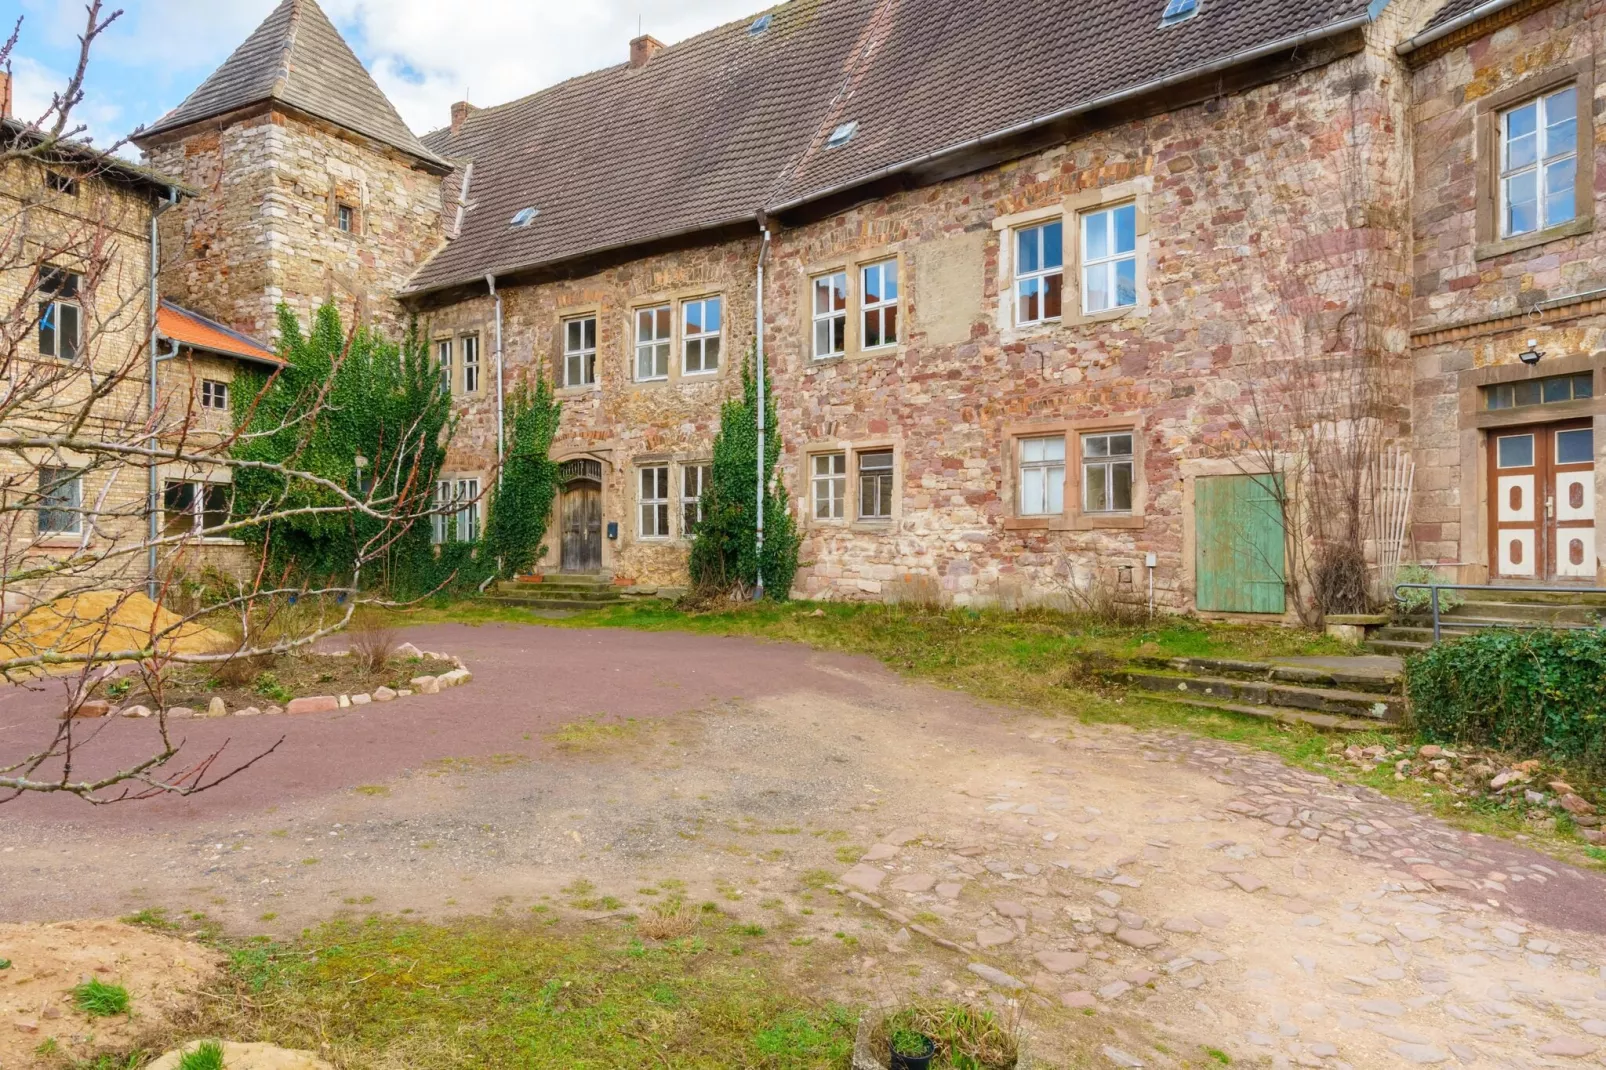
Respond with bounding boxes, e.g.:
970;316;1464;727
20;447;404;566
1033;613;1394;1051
1489;419;1596;582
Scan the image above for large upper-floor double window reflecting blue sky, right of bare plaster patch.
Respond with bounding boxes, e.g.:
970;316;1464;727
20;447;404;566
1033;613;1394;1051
993;178;1153;339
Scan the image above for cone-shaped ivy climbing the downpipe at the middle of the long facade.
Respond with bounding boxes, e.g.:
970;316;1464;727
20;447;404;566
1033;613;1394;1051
689;353;800;601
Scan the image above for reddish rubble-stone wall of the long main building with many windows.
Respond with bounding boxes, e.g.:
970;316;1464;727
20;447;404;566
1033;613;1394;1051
432;29;1408;609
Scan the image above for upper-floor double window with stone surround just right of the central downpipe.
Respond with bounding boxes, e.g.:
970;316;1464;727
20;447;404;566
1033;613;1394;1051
803;246;909;363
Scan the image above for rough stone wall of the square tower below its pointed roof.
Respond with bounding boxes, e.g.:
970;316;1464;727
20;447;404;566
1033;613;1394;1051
146;109;442;342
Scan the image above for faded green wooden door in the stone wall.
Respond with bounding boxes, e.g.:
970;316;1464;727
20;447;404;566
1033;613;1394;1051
1193;476;1286;614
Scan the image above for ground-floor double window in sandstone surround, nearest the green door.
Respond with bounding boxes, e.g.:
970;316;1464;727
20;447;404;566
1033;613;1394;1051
1001;415;1148;532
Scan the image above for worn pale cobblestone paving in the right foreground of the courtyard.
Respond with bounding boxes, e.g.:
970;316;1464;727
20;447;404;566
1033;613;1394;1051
842;719;1606;1070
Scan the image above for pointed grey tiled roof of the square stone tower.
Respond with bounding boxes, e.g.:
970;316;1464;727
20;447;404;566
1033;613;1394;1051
140;0;445;167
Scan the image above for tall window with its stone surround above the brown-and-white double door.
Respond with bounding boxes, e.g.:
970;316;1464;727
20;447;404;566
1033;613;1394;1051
1473;61;1595;260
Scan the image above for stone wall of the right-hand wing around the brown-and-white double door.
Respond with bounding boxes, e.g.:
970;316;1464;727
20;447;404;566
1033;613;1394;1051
1412;0;1606;583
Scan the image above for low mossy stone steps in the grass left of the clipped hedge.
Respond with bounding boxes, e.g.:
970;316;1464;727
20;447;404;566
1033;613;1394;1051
1102;655;1405;731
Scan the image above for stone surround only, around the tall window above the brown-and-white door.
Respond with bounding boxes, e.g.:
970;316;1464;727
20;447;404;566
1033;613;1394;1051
1473;59;1595;260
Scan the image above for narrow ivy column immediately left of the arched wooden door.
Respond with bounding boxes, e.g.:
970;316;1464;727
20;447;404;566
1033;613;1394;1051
485;376;562;577
